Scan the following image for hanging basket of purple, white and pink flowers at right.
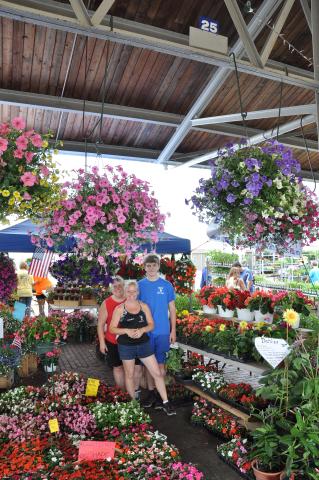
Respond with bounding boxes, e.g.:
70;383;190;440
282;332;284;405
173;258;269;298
191;142;319;252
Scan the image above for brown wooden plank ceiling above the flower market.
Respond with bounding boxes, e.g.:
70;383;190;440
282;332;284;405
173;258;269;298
0;0;319;174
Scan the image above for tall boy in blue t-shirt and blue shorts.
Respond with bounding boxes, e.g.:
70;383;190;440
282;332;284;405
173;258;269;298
138;254;176;409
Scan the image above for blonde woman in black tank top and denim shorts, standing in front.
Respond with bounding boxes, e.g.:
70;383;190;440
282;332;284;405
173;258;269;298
110;280;176;415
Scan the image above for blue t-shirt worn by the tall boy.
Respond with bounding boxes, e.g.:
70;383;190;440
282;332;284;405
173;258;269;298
138;278;175;335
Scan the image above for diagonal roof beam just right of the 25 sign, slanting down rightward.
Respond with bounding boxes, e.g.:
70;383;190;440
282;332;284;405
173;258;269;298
224;0;264;68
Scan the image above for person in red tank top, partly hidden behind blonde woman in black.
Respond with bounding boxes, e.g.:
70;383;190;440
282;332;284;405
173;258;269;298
97;275;142;390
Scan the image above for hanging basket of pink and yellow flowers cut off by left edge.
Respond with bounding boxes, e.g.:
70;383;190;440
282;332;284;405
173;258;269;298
0;117;60;221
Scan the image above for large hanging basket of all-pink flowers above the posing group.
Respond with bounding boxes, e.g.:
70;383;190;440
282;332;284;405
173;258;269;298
36;165;165;265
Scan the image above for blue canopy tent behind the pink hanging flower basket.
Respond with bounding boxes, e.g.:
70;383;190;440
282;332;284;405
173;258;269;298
0;220;191;254
